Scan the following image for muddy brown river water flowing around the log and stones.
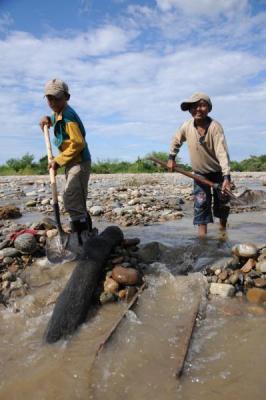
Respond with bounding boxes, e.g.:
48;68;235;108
0;211;266;400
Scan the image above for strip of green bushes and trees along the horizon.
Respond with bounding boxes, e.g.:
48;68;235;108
0;151;266;175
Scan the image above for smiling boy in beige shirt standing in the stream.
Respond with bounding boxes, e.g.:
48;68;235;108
167;92;230;237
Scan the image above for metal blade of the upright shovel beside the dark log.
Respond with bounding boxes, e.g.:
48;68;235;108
46;234;76;264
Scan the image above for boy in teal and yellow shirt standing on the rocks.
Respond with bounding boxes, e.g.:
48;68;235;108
40;79;92;244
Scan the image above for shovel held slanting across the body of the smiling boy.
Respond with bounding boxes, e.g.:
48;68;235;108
148;157;266;207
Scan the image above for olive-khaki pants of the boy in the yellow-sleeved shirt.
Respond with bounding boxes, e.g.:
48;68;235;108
63;161;91;221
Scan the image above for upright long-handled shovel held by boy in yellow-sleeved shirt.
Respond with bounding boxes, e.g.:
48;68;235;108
43;125;76;264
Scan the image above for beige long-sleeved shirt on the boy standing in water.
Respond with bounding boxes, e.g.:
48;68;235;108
169;118;230;176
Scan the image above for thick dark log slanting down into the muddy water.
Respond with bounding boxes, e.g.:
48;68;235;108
44;226;123;343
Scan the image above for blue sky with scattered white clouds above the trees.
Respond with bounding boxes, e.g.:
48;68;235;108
0;0;266;163
